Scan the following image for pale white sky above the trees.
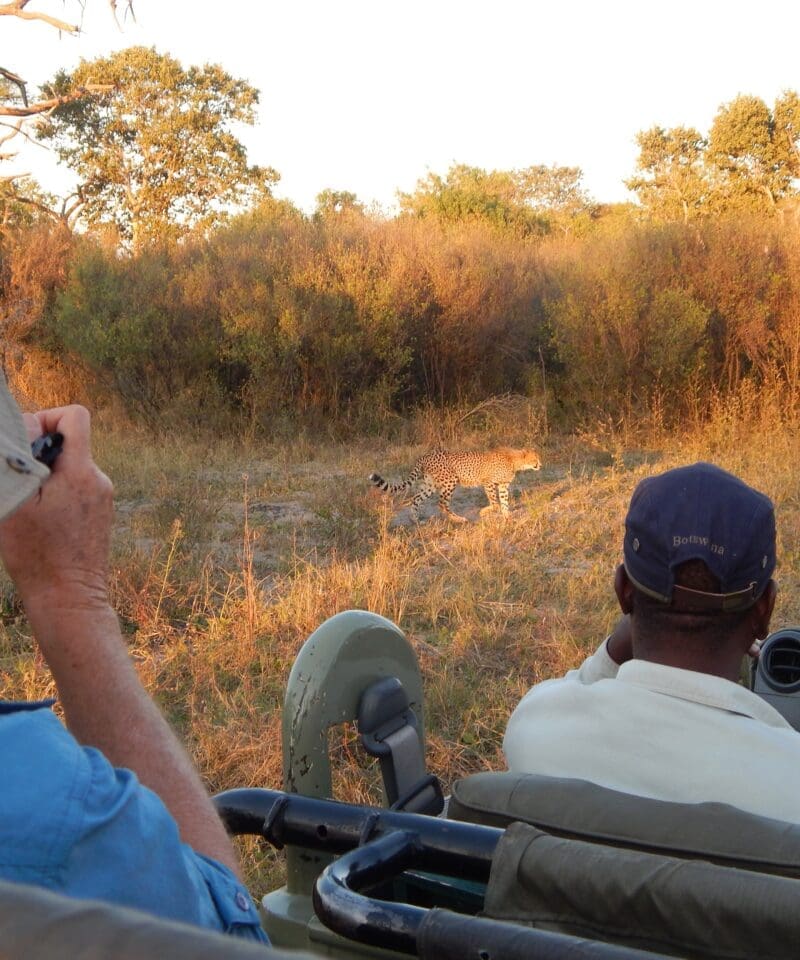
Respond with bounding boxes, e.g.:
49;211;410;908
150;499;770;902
0;0;800;212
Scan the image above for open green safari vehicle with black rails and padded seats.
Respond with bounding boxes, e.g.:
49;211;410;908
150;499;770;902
209;611;800;960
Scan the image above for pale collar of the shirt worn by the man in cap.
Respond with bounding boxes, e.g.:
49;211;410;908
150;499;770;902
617;660;792;730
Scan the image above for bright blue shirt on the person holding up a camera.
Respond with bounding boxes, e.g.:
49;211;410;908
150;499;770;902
0;701;267;942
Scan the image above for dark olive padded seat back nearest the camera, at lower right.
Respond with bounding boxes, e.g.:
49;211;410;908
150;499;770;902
485;823;800;960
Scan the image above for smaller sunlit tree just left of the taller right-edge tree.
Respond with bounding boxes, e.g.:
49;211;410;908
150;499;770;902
625;127;707;223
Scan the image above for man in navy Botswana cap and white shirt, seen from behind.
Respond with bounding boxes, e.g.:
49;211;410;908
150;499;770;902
503;463;800;822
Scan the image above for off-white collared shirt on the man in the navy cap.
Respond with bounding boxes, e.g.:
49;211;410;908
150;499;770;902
503;641;800;823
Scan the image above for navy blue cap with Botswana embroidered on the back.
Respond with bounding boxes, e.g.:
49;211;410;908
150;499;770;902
623;463;775;611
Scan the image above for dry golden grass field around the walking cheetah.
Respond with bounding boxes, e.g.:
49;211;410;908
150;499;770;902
0;388;800;893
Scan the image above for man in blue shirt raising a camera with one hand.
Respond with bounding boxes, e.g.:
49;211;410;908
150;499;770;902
0;378;266;942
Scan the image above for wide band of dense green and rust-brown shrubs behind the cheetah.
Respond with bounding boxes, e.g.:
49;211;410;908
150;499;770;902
7;209;800;431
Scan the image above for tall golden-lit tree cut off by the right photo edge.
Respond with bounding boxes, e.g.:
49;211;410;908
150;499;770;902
707;91;800;212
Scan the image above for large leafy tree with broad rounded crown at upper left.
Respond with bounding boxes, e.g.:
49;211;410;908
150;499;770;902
37;47;278;249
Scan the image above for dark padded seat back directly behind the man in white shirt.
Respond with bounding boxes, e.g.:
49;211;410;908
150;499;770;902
447;772;800;878
